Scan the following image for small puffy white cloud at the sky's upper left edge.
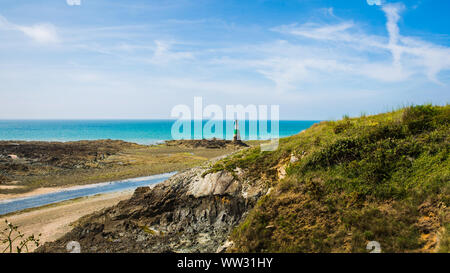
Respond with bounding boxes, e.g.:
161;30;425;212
0;15;59;44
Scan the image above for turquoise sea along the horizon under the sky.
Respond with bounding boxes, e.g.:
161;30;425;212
0;120;319;144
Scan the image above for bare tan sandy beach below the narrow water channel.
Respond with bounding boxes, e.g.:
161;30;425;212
0;190;133;253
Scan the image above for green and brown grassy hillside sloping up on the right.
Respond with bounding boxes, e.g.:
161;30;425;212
207;105;450;252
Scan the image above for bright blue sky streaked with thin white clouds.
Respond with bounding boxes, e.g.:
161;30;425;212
0;0;450;120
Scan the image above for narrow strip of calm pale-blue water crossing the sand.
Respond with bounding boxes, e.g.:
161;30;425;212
0;173;175;215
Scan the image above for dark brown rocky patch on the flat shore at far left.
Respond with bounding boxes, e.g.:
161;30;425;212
0;140;140;184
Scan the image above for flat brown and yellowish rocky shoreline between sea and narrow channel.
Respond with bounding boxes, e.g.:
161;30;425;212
0;139;246;198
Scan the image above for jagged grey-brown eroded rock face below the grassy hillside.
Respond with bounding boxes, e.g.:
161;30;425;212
37;165;267;252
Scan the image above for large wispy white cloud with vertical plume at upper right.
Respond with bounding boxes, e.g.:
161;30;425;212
252;2;450;90
